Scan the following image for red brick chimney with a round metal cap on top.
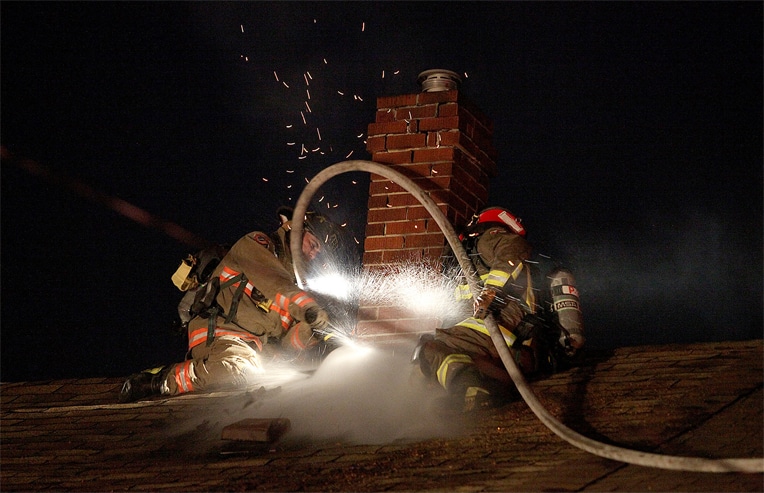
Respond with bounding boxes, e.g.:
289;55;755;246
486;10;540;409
357;70;497;337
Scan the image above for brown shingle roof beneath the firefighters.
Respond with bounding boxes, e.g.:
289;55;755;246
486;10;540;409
0;340;764;491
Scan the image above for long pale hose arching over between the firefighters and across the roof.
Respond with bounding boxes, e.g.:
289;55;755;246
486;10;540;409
289;160;764;473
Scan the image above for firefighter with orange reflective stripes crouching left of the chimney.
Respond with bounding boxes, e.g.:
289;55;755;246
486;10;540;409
119;208;338;402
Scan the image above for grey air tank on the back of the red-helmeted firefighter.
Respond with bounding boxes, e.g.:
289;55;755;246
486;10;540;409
548;268;586;351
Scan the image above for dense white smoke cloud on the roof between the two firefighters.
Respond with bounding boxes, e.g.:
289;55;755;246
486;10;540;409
248;346;466;444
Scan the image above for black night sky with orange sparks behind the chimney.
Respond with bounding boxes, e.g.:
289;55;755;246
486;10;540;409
0;2;764;381
